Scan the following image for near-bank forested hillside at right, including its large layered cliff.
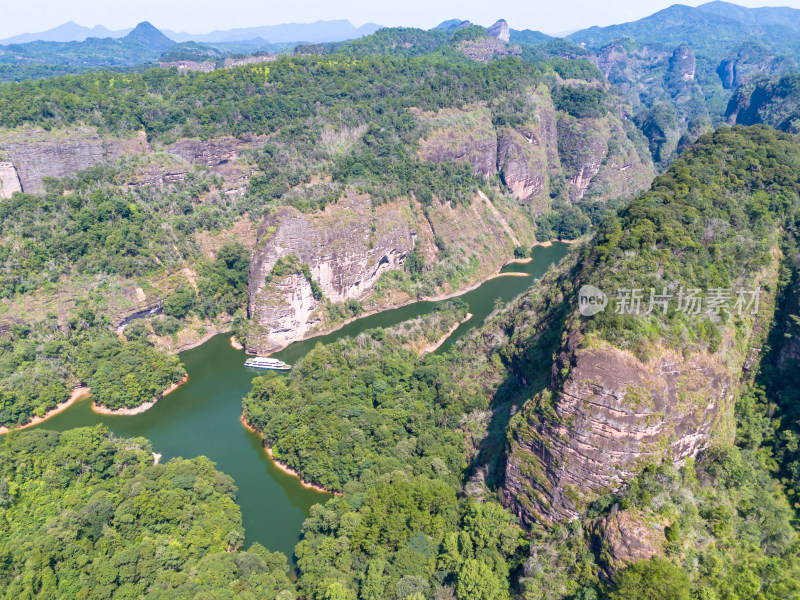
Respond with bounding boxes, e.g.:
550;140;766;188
234;128;800;599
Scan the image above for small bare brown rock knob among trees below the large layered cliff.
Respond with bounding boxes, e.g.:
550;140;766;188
592;510;666;577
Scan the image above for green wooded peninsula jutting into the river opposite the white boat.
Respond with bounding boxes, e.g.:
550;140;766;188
244;301;466;490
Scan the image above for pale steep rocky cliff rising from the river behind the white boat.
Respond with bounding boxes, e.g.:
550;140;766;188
248;190;533;353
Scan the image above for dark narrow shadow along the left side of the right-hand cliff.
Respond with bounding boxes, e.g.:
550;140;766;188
467;294;574;490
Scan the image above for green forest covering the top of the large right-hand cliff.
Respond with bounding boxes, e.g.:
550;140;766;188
587;127;800;356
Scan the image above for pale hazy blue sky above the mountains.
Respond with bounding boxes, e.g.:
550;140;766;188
0;0;800;39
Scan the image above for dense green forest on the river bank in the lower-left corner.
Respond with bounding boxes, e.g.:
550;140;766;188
0;427;295;600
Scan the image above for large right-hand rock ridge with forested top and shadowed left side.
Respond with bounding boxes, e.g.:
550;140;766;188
490;128;796;524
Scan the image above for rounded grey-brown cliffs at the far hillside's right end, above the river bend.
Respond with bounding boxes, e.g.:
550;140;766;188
416;89;654;207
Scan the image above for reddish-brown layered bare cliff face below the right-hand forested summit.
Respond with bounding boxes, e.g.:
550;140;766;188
503;336;735;523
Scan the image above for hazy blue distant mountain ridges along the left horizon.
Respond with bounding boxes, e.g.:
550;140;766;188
0;19;381;45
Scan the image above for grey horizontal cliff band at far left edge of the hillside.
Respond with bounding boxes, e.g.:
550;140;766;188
0;127;150;194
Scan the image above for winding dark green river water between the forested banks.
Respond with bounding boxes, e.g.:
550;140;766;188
31;243;568;557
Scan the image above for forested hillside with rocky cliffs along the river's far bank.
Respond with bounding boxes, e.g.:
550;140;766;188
0;51;652;426
